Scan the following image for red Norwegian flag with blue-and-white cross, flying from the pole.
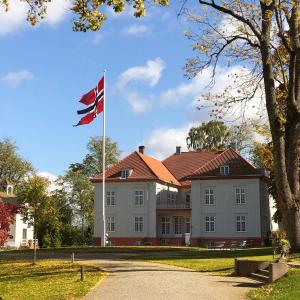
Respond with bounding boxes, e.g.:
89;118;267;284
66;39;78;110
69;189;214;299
74;76;104;126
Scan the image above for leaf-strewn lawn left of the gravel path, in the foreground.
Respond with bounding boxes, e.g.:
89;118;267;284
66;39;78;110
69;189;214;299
0;260;104;300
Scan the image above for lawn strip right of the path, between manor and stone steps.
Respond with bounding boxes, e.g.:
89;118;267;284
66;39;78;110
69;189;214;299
131;248;273;274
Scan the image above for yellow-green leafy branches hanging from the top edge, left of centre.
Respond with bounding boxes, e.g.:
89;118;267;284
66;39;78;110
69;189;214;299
0;0;169;32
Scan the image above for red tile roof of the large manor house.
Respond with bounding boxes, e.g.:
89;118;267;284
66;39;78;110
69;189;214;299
92;148;262;187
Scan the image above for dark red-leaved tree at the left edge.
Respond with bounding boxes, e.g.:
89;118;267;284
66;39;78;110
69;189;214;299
0;202;20;247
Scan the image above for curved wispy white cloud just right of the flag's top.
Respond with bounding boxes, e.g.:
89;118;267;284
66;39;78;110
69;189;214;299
117;57;165;89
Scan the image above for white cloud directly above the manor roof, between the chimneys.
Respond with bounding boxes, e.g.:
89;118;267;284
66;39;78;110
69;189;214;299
144;123;197;160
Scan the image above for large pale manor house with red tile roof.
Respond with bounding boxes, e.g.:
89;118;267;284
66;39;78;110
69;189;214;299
92;146;271;246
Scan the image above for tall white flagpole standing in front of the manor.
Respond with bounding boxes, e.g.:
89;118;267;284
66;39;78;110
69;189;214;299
101;70;106;247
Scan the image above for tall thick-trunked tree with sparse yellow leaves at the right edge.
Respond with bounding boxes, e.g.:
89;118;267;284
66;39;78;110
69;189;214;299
182;0;300;251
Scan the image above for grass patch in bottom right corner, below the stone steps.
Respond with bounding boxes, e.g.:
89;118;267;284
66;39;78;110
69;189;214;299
248;269;300;300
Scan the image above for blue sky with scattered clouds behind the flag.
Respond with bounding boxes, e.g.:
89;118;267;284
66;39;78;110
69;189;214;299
0;0;260;175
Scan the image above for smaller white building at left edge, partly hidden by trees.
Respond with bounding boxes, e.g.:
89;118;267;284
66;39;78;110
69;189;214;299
0;181;33;248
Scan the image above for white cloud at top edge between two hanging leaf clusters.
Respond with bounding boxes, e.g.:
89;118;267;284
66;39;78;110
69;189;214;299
45;0;72;25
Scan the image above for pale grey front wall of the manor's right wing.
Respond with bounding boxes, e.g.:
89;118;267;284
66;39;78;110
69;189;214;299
191;179;261;238
